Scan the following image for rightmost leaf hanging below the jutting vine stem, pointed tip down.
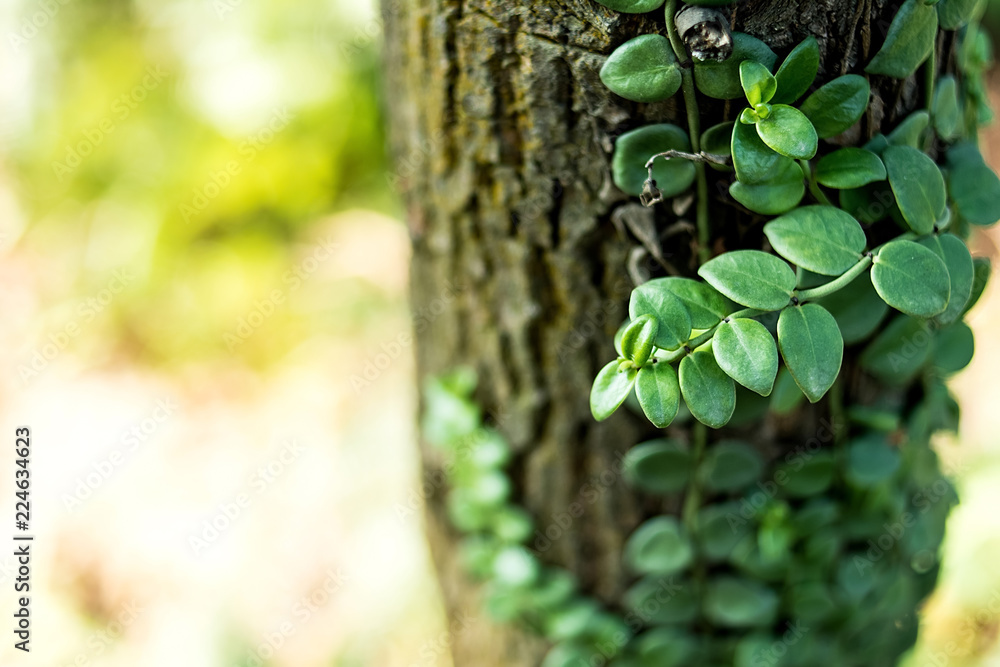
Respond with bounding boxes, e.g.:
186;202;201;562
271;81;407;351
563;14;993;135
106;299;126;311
778;303;844;403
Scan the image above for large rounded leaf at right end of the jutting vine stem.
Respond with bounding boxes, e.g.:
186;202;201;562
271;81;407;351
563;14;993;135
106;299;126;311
872;241;951;317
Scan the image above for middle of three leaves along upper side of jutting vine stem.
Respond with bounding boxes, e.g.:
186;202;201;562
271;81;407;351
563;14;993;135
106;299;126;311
698;250;795;310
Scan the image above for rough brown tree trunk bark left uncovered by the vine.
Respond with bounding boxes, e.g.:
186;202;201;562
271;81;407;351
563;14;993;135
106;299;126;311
384;0;936;667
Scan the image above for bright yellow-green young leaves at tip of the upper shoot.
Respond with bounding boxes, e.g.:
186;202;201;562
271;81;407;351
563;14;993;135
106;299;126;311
740;60;819;160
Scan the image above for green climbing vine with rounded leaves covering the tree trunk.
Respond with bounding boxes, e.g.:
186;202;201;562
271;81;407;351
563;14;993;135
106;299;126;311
424;0;1000;667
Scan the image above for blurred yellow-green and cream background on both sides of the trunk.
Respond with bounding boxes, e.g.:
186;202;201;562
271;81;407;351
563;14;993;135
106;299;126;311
0;0;1000;667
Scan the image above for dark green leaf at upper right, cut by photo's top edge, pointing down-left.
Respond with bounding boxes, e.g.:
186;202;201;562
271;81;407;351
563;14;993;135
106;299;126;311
865;0;937;79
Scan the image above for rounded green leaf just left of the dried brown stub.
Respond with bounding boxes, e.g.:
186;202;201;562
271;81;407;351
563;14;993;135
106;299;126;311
601;35;681;102
